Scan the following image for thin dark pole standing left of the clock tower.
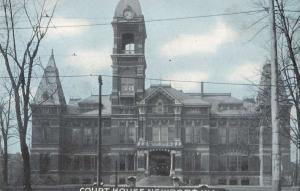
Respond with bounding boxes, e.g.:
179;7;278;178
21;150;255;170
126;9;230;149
97;75;102;186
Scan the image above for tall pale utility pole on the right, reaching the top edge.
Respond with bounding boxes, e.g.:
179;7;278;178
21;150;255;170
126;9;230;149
269;0;281;191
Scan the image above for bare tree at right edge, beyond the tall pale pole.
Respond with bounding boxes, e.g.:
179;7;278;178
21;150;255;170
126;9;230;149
275;0;300;185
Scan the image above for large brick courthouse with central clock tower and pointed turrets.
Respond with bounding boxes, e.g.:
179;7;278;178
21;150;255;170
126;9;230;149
31;0;290;185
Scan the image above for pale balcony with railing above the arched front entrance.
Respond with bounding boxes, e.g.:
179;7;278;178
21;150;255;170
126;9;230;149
137;138;182;148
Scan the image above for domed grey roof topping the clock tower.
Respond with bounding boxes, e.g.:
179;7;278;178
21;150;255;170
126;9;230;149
115;0;143;17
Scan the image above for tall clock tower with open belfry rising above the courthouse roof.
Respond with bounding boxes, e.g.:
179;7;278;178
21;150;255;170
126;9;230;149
111;0;147;106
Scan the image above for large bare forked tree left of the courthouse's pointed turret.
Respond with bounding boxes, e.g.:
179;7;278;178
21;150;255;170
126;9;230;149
0;0;55;191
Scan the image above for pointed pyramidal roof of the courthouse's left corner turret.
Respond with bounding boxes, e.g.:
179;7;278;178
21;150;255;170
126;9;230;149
33;50;66;105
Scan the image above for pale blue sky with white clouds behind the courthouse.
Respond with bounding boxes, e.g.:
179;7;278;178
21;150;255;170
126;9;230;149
2;0;294;155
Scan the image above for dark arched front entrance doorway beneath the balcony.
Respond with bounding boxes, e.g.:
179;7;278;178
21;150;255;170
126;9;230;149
149;151;171;176
